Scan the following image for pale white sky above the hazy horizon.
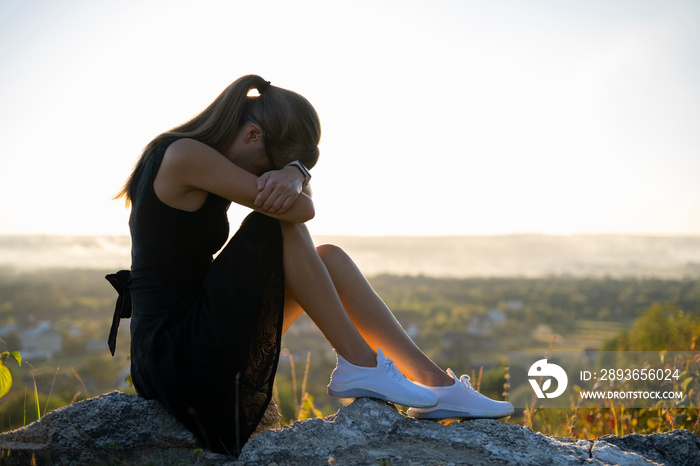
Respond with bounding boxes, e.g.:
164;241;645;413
0;0;700;235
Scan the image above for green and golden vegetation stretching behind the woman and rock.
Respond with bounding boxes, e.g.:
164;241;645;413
0;269;700;437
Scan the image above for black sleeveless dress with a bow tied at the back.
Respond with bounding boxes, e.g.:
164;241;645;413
107;138;284;455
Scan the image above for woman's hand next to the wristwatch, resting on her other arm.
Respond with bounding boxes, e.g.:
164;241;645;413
254;166;304;215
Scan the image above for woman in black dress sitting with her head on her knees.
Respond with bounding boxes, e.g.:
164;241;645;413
107;75;513;454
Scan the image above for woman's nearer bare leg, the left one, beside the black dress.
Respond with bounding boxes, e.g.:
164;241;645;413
280;222;377;367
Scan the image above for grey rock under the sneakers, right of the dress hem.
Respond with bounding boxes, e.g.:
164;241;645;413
239;398;700;466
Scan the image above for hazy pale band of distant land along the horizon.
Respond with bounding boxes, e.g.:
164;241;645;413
0;235;700;279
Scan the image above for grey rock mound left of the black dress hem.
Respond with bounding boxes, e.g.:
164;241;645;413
0;391;280;465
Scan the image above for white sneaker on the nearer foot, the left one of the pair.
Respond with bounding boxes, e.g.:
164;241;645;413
328;350;438;408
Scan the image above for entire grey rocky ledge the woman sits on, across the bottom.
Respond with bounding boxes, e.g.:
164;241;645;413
0;392;700;466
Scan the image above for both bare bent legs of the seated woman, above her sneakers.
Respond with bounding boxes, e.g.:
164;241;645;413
282;222;454;386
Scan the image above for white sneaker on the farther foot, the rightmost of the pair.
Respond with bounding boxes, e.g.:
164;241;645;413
406;369;513;419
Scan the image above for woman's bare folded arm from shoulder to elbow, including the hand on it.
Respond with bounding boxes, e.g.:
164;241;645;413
153;139;315;223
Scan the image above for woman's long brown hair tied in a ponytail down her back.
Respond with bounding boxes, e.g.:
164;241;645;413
115;74;321;206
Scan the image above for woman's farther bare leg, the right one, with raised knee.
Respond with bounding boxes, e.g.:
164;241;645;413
318;245;454;386
